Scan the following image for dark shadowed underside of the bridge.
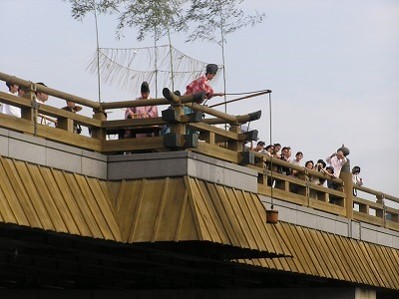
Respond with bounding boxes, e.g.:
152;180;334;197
0;224;364;289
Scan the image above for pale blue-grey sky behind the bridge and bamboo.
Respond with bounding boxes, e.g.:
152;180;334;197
0;0;399;197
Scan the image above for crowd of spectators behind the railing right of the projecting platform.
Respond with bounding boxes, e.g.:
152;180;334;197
251;141;363;195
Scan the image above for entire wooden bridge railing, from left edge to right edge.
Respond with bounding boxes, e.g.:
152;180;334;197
0;73;399;231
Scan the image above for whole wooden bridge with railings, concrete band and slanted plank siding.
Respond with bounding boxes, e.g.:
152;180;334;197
0;73;399;298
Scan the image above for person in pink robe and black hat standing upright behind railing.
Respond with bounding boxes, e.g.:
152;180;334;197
124;82;158;138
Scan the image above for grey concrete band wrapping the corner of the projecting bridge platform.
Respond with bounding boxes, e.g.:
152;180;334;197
108;151;258;192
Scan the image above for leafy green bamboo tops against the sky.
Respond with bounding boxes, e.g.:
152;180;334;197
63;0;264;44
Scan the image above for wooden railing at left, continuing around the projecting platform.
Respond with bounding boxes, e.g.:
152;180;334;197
0;73;260;164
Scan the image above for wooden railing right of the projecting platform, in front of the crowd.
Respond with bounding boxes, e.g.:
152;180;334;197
249;153;399;231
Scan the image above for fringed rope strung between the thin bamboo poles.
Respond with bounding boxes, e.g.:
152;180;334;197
87;45;223;93
